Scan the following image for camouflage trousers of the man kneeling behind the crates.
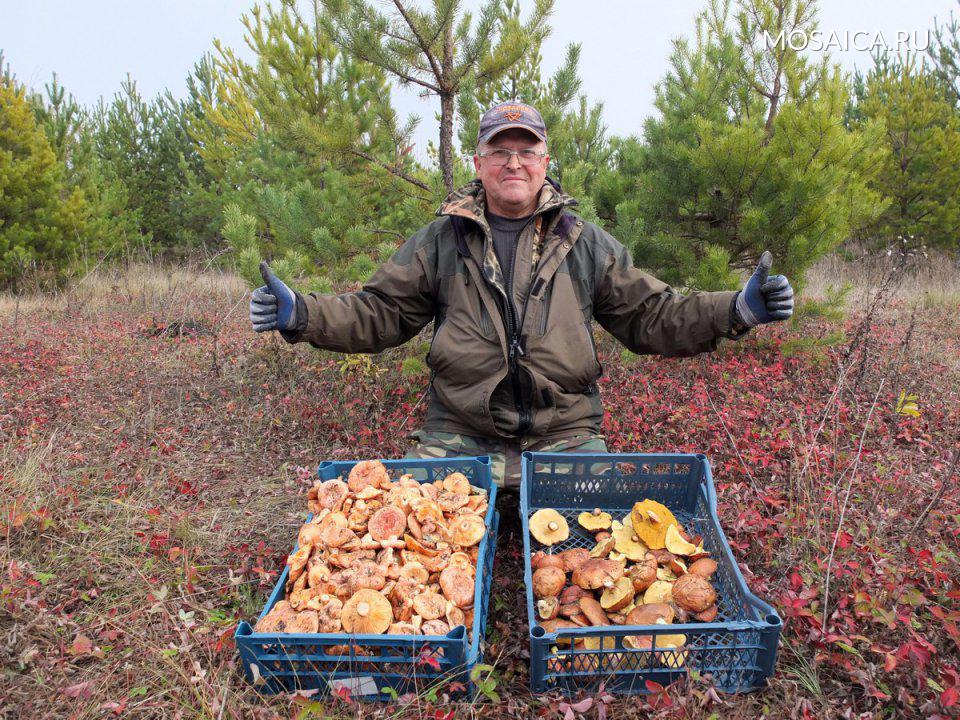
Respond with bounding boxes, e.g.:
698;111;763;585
406;430;607;490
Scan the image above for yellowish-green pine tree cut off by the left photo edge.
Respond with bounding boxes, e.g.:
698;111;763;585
0;78;86;291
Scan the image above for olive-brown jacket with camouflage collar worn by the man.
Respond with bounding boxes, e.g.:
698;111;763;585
283;180;742;439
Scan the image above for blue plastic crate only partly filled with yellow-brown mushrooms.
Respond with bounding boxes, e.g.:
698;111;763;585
520;452;782;693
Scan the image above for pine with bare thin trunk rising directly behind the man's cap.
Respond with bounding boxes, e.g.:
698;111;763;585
323;0;553;192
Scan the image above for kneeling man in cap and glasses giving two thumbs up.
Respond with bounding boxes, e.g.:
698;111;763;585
250;102;793;487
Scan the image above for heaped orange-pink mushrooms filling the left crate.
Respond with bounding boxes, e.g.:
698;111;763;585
254;460;487;640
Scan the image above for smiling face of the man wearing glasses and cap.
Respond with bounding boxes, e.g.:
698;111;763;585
473;128;550;217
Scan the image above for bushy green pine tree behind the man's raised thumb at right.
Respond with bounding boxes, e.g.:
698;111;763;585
628;0;883;289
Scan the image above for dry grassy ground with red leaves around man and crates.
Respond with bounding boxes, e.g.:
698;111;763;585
0;261;960;718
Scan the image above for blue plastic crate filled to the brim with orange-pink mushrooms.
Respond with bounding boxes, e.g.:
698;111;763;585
234;456;500;700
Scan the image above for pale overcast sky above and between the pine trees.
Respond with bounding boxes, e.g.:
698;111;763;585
0;0;960;157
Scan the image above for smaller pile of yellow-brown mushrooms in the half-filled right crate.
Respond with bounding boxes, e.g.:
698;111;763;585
529;500;718;669
